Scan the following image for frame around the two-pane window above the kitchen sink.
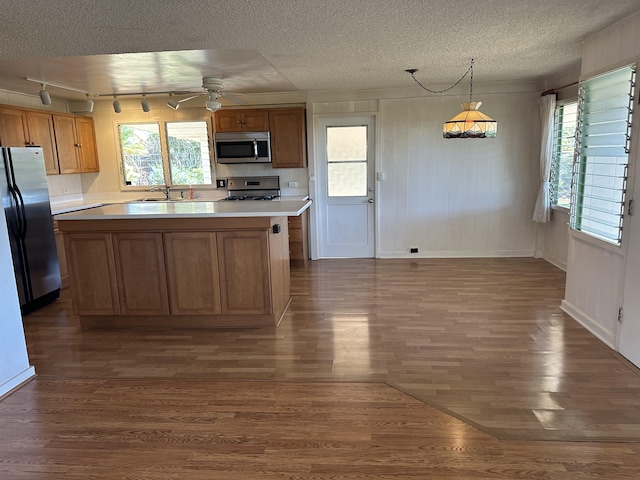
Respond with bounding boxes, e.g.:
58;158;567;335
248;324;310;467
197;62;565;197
113;115;216;192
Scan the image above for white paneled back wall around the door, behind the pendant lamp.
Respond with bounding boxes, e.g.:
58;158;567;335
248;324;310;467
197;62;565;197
309;83;542;258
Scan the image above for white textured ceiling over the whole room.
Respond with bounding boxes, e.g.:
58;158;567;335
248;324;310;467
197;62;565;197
0;0;640;99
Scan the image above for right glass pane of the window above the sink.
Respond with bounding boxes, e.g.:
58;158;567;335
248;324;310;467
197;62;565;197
166;121;211;185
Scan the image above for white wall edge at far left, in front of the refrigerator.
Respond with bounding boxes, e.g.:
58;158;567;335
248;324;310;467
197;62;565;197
0;209;35;397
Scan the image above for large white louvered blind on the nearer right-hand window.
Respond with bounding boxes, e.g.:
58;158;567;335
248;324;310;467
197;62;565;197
570;65;636;245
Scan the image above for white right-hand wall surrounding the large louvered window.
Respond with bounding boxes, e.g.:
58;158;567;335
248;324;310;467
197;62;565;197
562;14;640;348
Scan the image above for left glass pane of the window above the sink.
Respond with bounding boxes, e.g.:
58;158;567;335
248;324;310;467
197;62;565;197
118;123;167;186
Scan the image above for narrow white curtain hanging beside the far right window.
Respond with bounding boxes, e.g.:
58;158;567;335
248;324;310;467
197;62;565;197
533;93;556;223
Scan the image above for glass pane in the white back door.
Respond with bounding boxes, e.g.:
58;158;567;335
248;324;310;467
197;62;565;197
327;125;367;197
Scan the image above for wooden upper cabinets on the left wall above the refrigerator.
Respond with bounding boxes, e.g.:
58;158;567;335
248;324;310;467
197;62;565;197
0;106;100;175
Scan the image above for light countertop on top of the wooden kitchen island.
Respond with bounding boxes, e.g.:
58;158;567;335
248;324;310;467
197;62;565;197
56;200;311;220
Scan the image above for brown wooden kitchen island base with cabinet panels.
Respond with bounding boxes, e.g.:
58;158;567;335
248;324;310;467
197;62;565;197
59;217;290;327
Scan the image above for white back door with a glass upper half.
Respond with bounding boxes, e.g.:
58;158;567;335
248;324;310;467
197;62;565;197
316;117;375;258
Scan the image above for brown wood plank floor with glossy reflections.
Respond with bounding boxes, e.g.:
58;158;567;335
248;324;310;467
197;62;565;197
0;259;640;480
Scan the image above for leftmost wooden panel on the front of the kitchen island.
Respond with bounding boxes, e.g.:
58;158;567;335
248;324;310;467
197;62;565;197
64;233;120;315
